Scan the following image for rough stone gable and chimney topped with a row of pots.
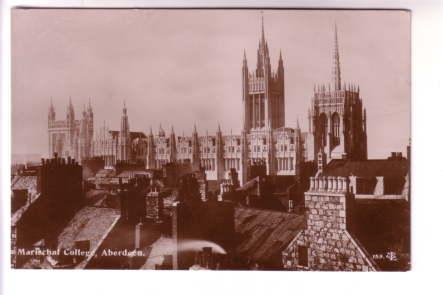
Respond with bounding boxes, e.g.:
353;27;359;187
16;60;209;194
283;177;376;271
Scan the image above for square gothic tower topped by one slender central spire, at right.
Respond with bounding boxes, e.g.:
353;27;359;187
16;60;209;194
308;27;367;163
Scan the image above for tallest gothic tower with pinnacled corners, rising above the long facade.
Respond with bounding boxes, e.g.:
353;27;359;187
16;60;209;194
242;16;285;133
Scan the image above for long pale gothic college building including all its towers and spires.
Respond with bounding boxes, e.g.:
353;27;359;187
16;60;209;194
49;19;367;184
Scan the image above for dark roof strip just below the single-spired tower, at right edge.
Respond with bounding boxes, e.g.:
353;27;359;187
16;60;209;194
322;158;409;178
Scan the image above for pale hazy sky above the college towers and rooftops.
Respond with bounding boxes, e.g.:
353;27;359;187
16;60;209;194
11;9;411;158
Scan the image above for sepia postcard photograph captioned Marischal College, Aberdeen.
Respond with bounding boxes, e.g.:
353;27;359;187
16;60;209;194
11;7;415;272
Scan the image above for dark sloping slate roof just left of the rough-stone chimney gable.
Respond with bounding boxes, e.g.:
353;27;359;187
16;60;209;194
235;207;305;266
